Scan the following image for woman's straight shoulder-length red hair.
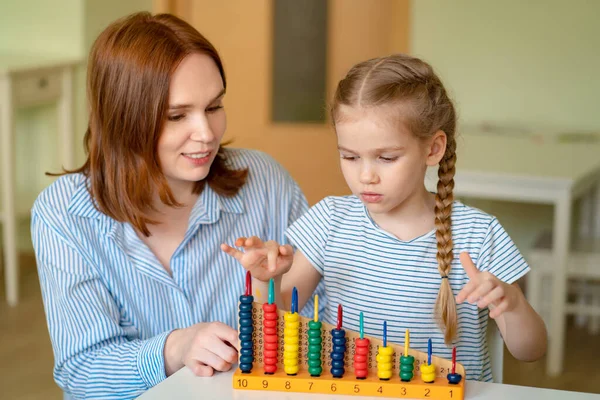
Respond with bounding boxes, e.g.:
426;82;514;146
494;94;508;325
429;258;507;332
55;12;248;236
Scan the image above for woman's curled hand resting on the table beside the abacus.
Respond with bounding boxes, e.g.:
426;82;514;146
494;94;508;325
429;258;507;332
164;322;238;376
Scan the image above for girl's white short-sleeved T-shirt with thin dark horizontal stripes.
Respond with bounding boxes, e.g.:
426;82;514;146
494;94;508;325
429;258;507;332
286;196;529;381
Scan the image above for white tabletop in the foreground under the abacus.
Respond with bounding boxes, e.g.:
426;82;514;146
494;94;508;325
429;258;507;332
139;368;600;400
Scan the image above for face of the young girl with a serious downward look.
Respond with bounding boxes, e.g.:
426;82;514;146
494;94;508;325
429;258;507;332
335;106;446;216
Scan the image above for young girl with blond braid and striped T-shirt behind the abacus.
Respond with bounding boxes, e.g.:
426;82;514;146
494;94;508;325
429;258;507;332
222;55;546;381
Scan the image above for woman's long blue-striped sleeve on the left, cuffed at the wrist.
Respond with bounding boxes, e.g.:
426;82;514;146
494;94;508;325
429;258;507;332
31;210;170;398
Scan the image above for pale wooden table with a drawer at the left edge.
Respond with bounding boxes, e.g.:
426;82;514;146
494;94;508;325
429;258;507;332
0;54;78;306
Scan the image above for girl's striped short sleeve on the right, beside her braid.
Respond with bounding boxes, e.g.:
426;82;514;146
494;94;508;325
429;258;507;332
476;218;531;283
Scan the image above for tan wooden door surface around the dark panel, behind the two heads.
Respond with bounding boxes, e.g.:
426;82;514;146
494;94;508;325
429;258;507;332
183;0;409;204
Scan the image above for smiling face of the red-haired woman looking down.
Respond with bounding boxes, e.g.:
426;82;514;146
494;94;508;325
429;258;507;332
157;54;227;195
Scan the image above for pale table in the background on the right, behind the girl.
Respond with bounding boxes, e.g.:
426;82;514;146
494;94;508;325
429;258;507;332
427;129;600;376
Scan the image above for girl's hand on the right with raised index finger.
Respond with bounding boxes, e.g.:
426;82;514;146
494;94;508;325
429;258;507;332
456;252;519;319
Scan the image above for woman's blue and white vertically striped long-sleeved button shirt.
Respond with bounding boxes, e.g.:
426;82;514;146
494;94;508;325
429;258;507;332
31;149;313;398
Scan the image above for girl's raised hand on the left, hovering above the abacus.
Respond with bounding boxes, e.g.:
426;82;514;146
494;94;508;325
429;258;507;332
221;236;294;282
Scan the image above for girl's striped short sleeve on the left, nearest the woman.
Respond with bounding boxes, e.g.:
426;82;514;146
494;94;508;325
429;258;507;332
286;198;331;275
